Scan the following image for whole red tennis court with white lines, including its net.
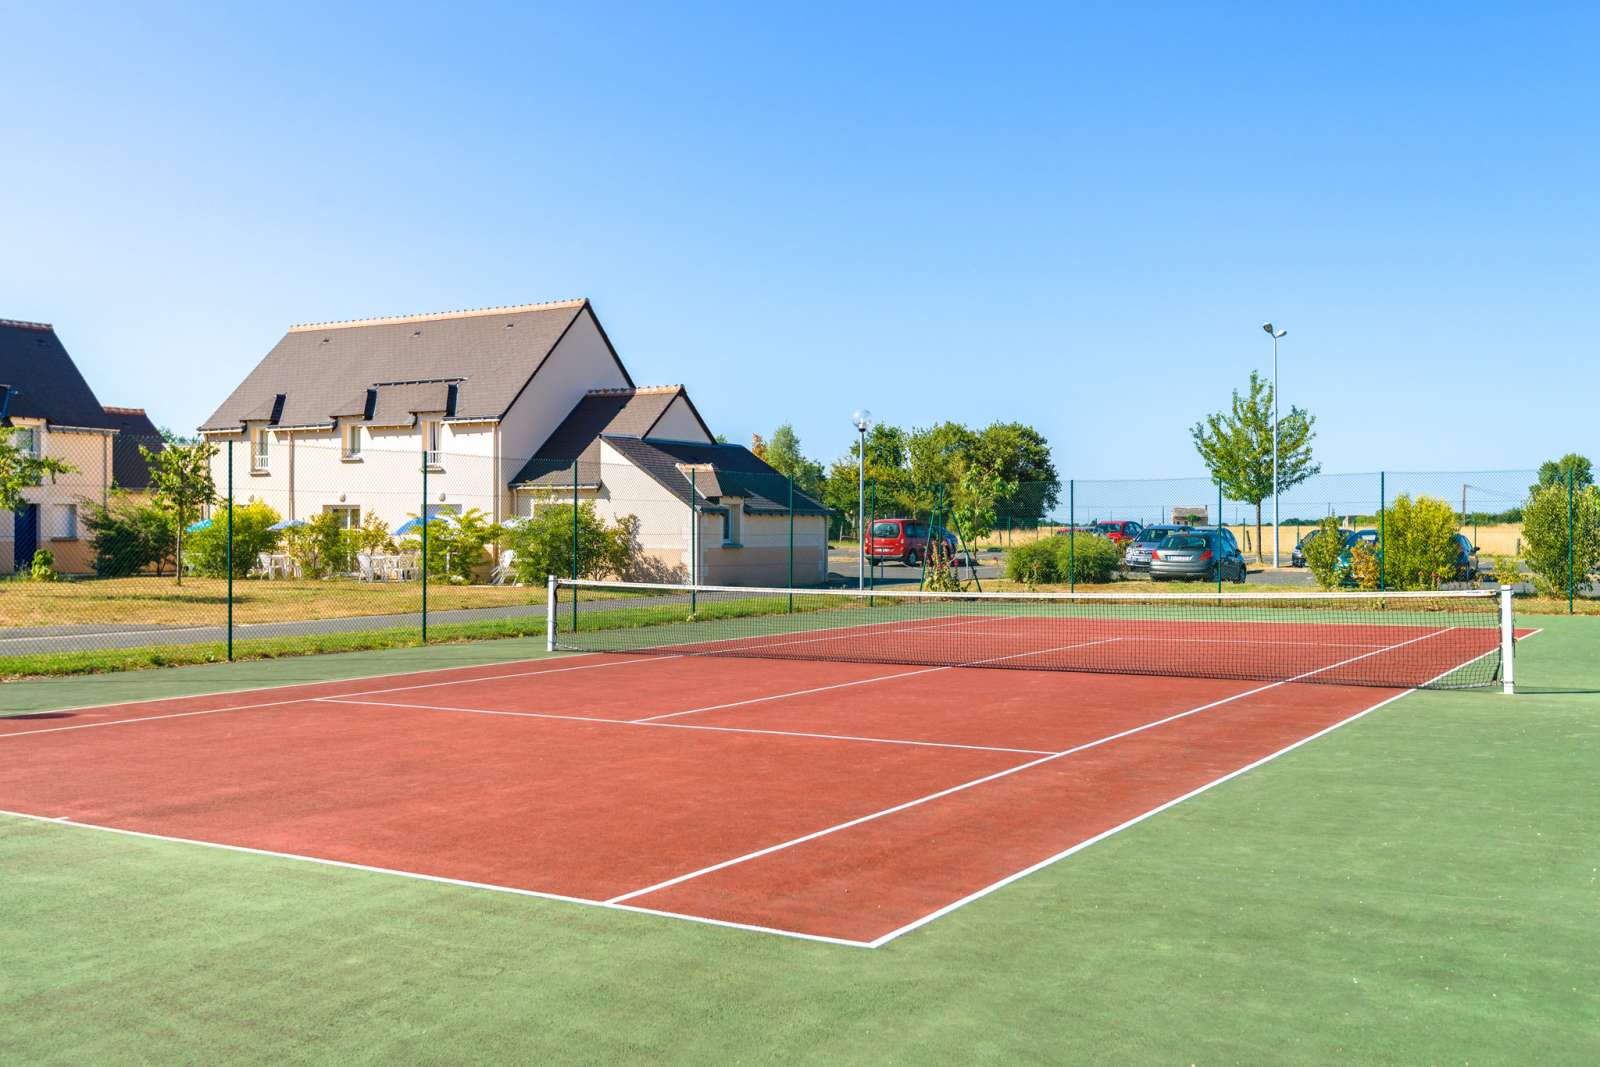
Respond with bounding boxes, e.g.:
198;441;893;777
0;582;1525;945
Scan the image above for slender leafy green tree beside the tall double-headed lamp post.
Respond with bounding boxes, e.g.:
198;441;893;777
1189;371;1322;563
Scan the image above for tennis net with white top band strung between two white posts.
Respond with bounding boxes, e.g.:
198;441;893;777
549;579;1510;689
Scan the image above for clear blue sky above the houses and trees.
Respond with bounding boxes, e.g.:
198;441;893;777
0;3;1600;478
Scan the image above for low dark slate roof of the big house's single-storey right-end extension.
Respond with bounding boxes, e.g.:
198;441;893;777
603;434;827;515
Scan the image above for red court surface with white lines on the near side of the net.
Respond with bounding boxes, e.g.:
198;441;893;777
0;627;1523;945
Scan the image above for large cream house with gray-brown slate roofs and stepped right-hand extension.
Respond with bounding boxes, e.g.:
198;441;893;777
200;301;827;584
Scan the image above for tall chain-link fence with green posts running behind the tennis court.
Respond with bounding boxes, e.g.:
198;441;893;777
0;430;1600;677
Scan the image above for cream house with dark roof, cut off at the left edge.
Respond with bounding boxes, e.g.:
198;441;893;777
0;318;162;574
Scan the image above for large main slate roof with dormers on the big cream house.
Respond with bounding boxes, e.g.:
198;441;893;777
200;301;632;430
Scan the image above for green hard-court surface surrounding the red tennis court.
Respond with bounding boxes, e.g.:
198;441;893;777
0;617;1600;1064
